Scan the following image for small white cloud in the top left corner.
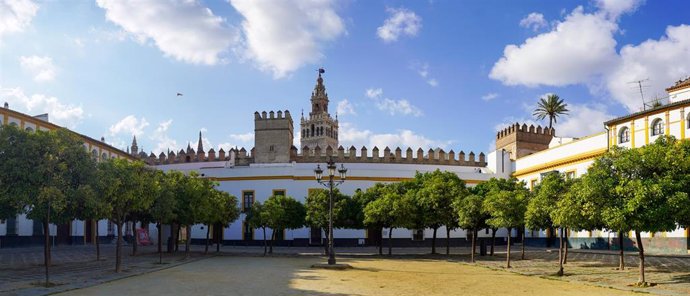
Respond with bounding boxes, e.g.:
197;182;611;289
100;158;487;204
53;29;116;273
0;0;38;44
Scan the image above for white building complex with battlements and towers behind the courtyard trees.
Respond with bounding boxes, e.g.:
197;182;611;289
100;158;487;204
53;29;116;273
0;74;690;253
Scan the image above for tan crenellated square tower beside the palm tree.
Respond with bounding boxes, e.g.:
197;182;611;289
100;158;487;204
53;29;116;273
496;122;556;160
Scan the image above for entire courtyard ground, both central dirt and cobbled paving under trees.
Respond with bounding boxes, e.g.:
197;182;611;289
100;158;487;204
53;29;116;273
0;245;690;295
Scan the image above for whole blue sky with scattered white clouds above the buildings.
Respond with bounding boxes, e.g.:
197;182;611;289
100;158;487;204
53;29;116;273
0;0;690;154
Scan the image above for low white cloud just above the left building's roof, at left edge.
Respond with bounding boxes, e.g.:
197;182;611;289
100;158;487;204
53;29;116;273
0;87;84;129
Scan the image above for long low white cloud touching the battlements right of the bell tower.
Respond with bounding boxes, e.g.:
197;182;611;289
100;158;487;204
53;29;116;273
338;122;453;153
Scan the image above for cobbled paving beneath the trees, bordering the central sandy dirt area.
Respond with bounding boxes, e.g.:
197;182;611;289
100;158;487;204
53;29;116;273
0;244;690;295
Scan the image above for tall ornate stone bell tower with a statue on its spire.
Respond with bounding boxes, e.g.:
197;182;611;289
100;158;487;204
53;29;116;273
300;68;338;151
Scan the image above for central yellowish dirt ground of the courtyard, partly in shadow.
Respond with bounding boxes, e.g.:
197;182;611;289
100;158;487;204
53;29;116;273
56;257;631;296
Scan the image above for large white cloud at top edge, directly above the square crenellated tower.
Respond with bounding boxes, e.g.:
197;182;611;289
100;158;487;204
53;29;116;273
230;0;346;78
